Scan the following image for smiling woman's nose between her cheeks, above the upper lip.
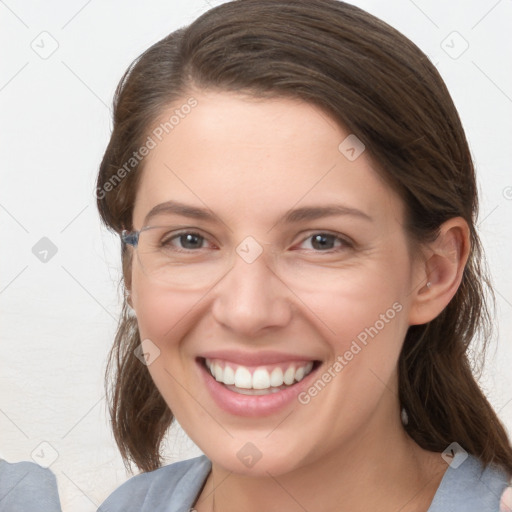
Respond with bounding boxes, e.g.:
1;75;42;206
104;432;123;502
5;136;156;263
212;246;292;338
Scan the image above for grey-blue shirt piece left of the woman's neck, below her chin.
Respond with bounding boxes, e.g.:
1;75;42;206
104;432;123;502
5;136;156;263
98;455;211;512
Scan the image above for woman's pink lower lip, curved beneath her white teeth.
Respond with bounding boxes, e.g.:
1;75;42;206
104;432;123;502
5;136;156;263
197;360;318;417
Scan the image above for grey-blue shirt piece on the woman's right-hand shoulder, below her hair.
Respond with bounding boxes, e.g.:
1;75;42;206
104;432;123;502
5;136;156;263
428;455;508;512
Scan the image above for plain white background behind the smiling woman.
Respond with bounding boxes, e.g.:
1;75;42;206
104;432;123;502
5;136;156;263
0;0;512;512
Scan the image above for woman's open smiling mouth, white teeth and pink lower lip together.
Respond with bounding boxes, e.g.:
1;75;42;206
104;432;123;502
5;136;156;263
196;357;322;417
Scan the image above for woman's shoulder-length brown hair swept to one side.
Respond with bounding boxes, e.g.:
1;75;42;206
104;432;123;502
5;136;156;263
97;0;512;474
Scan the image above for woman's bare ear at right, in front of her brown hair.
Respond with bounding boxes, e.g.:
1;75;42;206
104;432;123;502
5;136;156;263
409;217;470;325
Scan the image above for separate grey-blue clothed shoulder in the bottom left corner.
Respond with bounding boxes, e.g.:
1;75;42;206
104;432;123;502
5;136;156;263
0;460;61;512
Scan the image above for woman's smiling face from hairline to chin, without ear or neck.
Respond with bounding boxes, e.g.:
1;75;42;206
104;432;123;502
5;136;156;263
132;92;420;475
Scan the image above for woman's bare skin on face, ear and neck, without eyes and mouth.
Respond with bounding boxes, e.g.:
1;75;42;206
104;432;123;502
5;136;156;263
131;91;469;512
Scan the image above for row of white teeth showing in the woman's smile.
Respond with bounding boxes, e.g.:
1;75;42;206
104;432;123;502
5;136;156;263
206;359;313;391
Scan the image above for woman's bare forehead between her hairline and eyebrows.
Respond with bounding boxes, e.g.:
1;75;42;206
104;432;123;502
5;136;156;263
134;92;401;227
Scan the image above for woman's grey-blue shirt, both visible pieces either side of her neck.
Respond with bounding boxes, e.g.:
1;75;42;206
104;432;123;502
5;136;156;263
98;455;507;512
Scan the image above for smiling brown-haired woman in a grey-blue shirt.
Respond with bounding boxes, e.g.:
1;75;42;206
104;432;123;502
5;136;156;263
97;0;512;512
